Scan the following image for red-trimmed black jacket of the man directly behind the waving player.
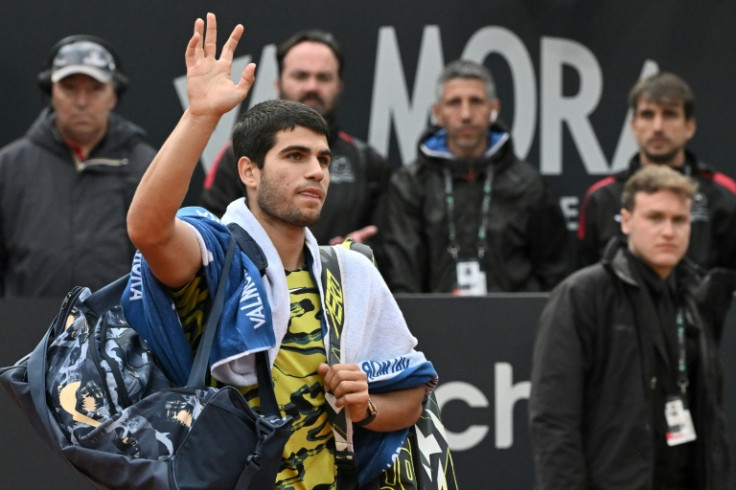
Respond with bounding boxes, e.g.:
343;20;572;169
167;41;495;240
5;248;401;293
196;125;391;247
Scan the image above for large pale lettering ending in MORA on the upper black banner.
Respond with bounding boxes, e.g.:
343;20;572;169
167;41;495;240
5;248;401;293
174;25;659;175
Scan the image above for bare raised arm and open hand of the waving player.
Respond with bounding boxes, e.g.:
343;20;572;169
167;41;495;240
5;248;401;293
128;13;255;287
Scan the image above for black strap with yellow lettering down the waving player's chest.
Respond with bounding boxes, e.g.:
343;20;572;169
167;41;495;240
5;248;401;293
319;245;358;490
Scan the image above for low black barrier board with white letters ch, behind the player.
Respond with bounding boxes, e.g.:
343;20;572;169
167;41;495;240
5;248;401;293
0;294;736;490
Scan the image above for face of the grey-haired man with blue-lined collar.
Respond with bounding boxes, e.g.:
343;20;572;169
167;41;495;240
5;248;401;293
433;78;498;158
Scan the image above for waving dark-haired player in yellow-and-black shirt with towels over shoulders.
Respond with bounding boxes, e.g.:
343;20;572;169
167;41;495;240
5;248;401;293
122;14;437;490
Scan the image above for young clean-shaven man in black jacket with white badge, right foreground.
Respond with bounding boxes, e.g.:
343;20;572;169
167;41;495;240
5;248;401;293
529;165;733;490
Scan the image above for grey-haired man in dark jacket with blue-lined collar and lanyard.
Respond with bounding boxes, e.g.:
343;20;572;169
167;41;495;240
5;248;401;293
383;60;569;294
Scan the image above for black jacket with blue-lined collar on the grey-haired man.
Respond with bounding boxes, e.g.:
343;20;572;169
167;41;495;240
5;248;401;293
382;124;569;293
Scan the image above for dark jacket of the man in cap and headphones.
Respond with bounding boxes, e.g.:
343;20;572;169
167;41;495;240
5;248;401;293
0;109;156;298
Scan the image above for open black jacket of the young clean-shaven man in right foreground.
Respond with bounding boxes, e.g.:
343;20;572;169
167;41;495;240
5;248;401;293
529;239;732;490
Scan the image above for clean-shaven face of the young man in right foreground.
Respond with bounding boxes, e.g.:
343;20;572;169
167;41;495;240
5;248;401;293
621;190;692;278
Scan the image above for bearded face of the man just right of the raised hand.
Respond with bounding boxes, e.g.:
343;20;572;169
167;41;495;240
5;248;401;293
276;41;342;116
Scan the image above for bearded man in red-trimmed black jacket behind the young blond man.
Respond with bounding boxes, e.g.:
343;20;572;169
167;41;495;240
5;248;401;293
578;73;736;269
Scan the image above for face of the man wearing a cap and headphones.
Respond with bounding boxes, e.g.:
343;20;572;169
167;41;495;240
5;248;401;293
51;74;117;146
